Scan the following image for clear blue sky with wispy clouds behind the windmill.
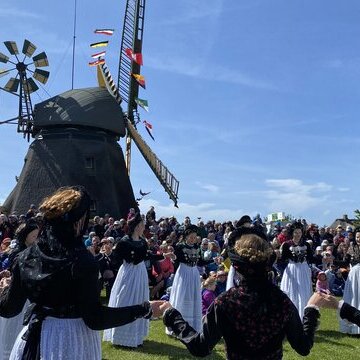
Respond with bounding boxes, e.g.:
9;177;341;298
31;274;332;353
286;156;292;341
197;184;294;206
0;0;360;225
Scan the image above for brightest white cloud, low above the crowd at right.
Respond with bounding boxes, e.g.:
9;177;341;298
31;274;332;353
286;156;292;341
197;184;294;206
265;179;332;216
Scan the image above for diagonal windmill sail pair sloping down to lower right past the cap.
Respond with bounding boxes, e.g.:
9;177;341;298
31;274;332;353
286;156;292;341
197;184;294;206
97;64;179;207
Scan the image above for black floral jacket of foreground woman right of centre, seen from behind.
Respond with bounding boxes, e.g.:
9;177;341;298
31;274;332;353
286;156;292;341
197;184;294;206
164;285;320;360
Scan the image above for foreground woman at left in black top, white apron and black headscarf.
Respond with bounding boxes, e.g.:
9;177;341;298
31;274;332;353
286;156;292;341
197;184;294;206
0;186;163;360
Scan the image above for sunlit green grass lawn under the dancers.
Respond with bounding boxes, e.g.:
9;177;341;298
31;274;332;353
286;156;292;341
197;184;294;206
102;309;360;360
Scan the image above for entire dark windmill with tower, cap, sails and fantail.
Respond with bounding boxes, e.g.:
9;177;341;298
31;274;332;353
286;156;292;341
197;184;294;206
0;0;179;217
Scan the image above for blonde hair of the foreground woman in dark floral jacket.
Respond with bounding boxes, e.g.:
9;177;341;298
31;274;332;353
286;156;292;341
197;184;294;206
235;234;273;263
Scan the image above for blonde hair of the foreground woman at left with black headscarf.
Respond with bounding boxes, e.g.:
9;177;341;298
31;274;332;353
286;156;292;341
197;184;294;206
39;188;81;219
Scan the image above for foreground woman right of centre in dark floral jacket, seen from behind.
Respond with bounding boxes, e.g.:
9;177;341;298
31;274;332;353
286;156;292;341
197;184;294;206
164;228;320;360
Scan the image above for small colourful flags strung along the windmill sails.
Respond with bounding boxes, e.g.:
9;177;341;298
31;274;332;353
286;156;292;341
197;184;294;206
89;29;155;141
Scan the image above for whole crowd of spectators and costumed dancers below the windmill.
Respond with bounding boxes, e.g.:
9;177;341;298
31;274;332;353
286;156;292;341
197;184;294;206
0;195;360;360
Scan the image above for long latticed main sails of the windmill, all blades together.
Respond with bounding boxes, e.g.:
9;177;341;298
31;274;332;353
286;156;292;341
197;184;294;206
98;0;179;207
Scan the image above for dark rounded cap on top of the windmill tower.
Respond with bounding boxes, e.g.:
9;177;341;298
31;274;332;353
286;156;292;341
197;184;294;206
34;87;125;136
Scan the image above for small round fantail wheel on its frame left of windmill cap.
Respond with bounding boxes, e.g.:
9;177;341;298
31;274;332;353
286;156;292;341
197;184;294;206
0;40;50;141
